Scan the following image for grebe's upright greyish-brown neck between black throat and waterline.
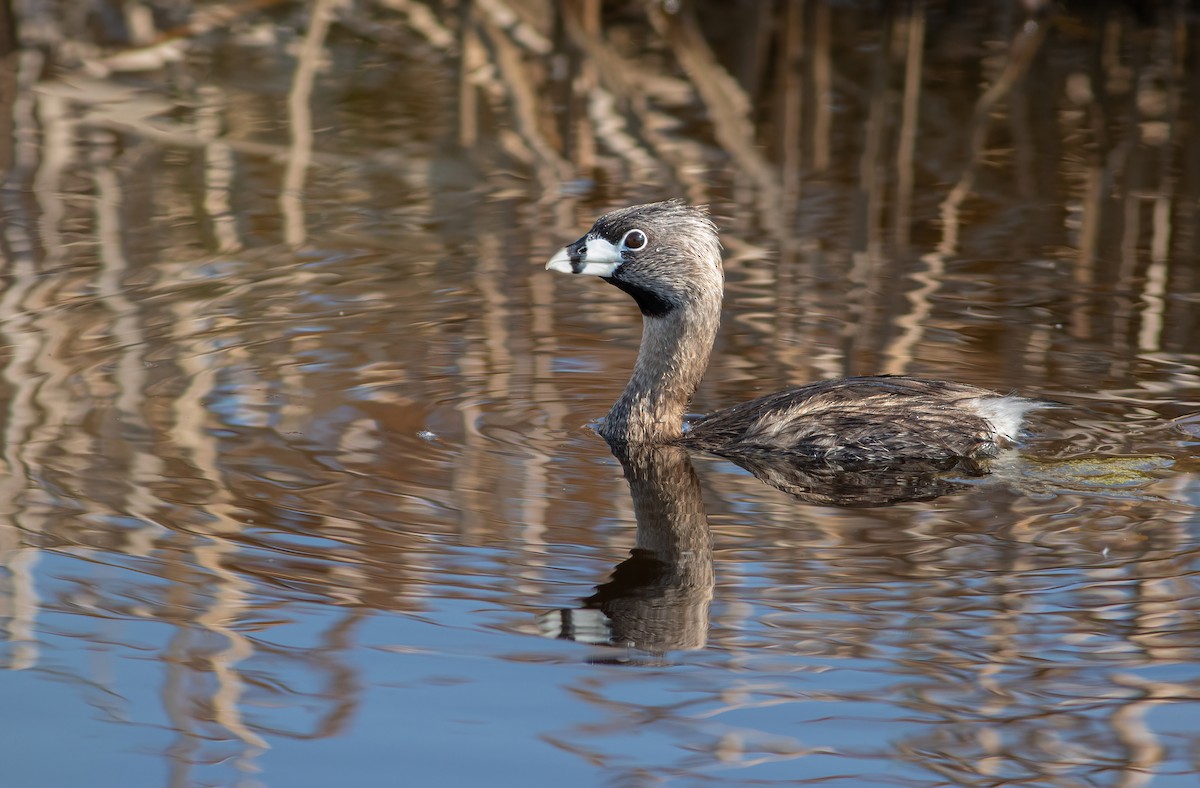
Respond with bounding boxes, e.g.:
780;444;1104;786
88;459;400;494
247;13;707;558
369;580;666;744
600;290;721;444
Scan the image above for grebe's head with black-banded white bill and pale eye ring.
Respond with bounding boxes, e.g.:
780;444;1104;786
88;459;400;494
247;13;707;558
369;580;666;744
546;200;724;318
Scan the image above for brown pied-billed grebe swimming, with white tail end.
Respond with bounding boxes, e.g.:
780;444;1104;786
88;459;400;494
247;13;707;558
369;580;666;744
546;200;1043;465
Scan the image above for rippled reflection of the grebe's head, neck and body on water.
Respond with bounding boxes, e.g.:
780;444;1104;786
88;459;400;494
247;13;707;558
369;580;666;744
539;441;983;655
